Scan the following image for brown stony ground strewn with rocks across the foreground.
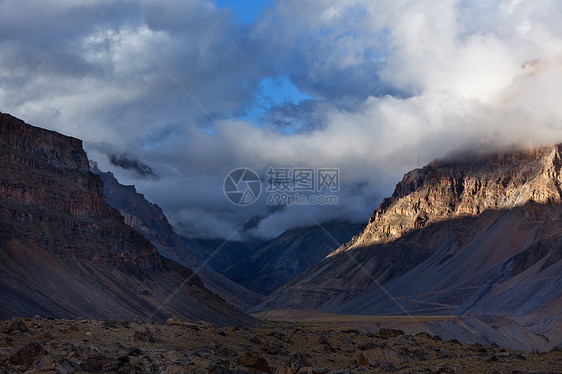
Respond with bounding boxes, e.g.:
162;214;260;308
0;318;562;374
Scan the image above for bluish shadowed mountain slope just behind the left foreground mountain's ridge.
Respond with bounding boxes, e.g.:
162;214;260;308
93;167;262;310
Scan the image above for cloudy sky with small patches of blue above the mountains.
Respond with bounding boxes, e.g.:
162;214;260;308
0;0;562;240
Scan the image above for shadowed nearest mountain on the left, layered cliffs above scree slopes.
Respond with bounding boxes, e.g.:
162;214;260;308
0;113;255;324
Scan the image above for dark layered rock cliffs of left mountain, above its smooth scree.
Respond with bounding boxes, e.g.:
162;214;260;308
0;114;162;271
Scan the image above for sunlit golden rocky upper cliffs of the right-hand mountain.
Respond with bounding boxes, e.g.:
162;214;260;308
334;145;562;253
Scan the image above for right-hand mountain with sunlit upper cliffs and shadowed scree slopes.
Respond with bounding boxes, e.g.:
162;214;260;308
254;145;562;343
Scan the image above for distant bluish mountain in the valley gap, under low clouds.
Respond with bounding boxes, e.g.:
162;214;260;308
224;222;363;295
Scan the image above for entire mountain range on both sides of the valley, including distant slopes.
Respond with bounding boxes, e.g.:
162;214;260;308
0;113;562;349
